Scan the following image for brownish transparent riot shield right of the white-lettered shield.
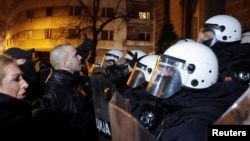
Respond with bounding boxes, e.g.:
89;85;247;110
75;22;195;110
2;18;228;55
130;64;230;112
109;93;157;141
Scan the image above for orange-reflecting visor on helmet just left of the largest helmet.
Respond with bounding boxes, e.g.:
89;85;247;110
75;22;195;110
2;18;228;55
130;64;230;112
127;63;146;88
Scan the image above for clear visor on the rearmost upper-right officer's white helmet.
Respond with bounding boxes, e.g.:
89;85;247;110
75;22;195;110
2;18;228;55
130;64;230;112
197;24;225;47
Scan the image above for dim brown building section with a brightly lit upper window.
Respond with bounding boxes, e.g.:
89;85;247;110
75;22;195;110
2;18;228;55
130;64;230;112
125;0;155;53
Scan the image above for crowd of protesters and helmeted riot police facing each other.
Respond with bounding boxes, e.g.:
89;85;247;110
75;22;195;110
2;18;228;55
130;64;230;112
0;15;250;141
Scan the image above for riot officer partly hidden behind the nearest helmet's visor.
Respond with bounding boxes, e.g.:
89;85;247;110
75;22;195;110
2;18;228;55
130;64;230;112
121;55;163;131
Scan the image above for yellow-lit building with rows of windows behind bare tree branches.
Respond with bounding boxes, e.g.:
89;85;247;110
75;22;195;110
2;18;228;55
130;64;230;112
0;0;155;60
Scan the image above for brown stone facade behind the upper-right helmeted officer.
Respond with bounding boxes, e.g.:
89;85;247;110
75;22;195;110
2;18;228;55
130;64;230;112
155;0;250;46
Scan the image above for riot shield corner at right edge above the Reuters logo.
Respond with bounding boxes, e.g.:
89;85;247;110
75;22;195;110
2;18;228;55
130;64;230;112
214;88;250;125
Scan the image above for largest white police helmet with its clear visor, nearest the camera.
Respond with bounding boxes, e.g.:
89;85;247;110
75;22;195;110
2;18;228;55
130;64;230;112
147;42;219;98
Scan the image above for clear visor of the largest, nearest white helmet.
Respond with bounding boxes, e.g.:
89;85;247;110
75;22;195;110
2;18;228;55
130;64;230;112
146;55;188;99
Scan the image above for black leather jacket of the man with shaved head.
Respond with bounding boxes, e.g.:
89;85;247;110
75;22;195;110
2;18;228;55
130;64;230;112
36;70;96;141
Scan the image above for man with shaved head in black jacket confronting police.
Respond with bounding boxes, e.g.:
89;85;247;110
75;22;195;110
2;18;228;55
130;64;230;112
36;44;97;141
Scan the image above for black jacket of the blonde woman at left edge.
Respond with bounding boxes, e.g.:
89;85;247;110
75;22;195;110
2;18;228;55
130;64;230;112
0;93;48;140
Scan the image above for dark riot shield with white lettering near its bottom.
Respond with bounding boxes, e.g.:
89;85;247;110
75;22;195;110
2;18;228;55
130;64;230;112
91;74;117;141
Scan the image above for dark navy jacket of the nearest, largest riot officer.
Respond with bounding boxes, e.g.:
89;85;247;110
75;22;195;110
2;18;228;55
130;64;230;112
123;81;248;141
